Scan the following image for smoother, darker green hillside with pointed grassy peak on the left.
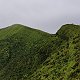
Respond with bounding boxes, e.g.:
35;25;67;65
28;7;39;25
0;25;53;80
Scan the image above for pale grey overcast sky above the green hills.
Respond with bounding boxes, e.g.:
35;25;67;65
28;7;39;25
0;0;80;33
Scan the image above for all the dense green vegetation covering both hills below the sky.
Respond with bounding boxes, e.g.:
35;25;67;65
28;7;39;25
0;24;80;80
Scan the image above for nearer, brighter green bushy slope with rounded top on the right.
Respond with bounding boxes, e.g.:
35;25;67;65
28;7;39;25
27;24;80;80
